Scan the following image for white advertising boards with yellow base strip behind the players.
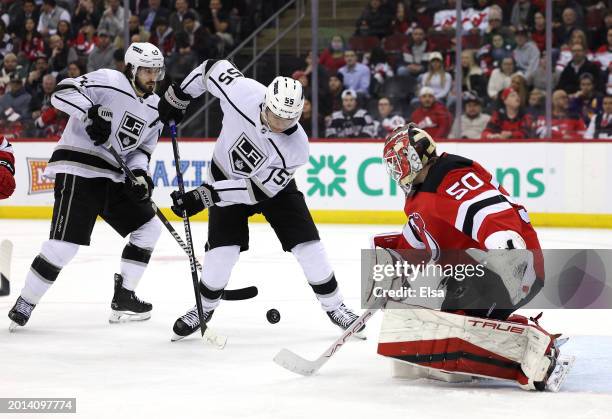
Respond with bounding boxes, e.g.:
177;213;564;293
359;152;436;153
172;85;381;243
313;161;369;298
0;139;612;227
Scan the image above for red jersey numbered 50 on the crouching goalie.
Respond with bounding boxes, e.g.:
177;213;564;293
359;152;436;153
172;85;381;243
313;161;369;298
375;153;543;286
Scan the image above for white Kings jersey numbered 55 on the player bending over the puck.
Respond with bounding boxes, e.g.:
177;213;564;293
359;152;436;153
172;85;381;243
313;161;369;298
181;60;309;206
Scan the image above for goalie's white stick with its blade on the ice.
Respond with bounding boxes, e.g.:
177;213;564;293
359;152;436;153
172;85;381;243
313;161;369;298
274;308;379;376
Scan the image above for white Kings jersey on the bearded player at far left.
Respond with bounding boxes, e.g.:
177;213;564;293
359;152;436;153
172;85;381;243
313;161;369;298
45;69;163;182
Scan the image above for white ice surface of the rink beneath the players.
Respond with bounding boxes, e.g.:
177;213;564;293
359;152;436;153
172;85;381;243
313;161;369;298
0;220;612;419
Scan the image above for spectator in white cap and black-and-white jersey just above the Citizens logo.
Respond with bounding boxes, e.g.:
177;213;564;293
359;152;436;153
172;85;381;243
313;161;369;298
325;89;376;138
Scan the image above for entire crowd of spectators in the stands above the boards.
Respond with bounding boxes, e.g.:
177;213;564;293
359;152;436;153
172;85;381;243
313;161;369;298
0;0;612;139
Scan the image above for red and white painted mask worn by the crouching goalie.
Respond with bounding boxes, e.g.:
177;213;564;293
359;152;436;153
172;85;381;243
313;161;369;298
383;122;436;193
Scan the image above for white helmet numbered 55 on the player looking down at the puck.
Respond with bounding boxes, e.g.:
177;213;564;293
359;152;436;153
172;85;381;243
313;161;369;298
264;76;304;130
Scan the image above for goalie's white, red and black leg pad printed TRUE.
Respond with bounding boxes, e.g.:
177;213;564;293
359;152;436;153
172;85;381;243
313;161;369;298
378;309;553;388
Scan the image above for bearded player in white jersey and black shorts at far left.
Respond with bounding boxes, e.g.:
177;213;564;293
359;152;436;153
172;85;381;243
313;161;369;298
9;43;164;328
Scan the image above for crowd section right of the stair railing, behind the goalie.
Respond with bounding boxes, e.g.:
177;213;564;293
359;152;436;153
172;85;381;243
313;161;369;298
293;0;612;140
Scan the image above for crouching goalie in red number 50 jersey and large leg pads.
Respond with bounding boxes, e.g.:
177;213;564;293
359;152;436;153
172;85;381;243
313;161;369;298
373;124;572;391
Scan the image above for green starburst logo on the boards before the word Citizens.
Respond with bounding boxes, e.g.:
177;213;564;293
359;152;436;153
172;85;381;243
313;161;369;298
306;155;346;196
